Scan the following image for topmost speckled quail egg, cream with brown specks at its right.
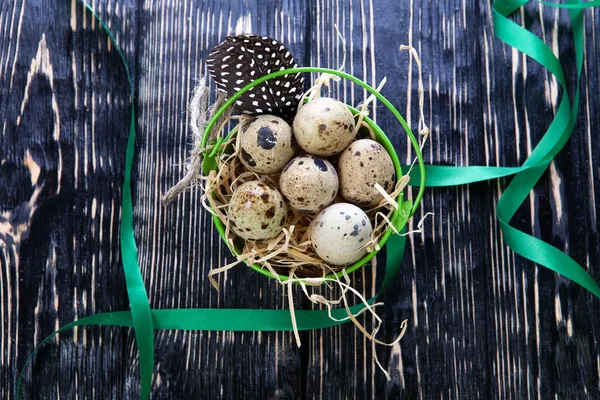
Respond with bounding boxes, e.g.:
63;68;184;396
292;97;354;156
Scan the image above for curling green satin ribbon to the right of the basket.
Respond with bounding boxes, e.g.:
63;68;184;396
410;0;600;298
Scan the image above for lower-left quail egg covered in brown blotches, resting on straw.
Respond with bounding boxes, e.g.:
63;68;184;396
227;181;287;240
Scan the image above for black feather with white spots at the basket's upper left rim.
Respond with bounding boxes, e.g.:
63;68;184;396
206;35;304;120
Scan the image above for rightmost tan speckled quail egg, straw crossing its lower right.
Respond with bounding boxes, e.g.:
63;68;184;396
338;139;396;207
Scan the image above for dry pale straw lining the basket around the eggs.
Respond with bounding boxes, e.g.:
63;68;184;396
203;105;408;284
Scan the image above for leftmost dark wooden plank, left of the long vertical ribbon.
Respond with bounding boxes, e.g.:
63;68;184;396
0;1;135;399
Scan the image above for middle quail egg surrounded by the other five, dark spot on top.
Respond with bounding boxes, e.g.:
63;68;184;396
279;156;339;213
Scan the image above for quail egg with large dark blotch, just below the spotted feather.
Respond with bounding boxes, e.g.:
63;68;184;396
239;115;294;174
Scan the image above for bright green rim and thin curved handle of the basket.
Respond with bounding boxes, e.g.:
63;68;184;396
202;67;425;281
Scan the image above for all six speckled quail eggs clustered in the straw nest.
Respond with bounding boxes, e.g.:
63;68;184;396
228;97;396;266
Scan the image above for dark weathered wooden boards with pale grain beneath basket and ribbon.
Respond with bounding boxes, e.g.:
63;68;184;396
0;0;600;399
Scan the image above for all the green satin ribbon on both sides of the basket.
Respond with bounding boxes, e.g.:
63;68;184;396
17;0;600;399
